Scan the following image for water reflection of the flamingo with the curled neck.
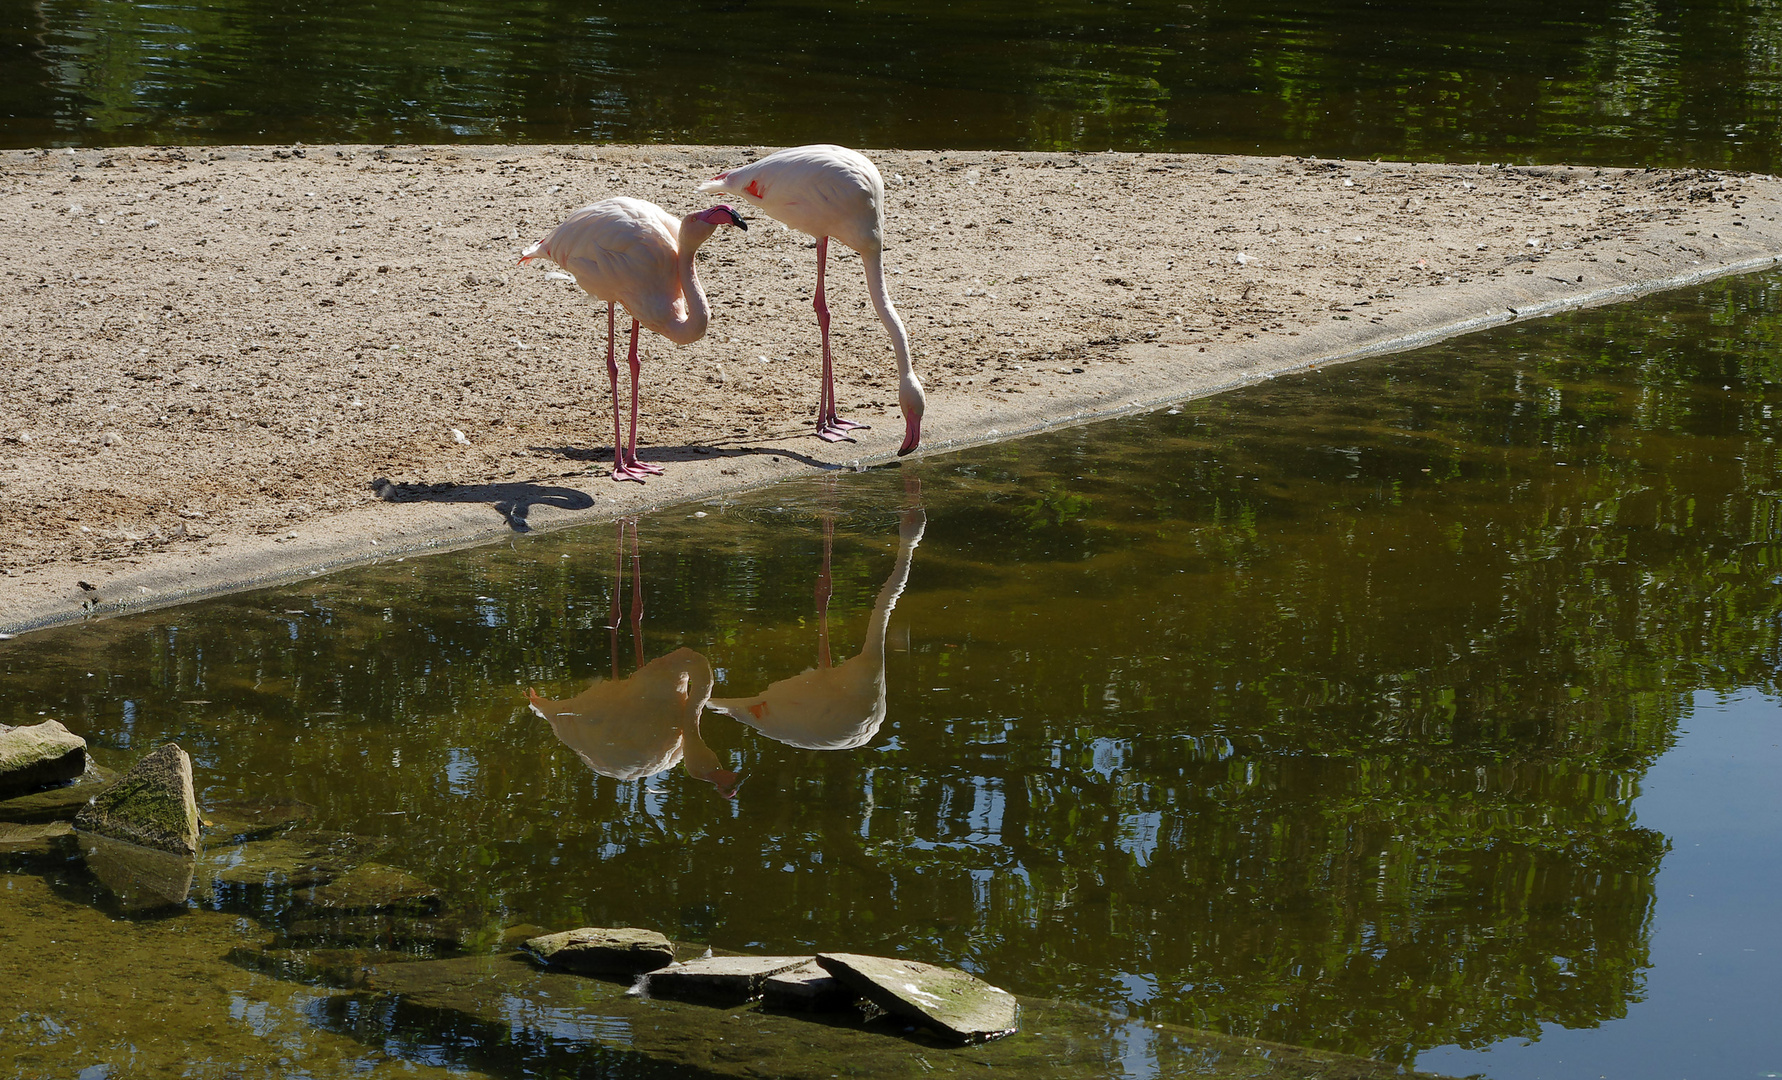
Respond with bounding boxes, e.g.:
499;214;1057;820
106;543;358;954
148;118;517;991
526;520;741;798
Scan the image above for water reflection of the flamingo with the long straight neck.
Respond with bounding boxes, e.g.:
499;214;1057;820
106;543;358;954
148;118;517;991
711;479;928;750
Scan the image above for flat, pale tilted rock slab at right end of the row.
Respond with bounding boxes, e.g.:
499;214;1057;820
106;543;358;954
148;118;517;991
816;952;1019;1043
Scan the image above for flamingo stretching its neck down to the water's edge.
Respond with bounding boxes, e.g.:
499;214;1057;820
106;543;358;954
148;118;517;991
699;144;925;456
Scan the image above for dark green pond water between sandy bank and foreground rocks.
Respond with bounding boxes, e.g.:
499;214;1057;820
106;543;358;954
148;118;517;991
0;276;1782;1078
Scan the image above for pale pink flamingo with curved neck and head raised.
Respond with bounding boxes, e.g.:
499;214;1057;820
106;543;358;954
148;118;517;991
520;196;748;483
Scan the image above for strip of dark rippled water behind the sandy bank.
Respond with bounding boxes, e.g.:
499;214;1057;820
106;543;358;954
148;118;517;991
10;0;1782;171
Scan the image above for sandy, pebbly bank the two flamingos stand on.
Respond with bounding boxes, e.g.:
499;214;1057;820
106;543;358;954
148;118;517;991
0;146;1782;633
